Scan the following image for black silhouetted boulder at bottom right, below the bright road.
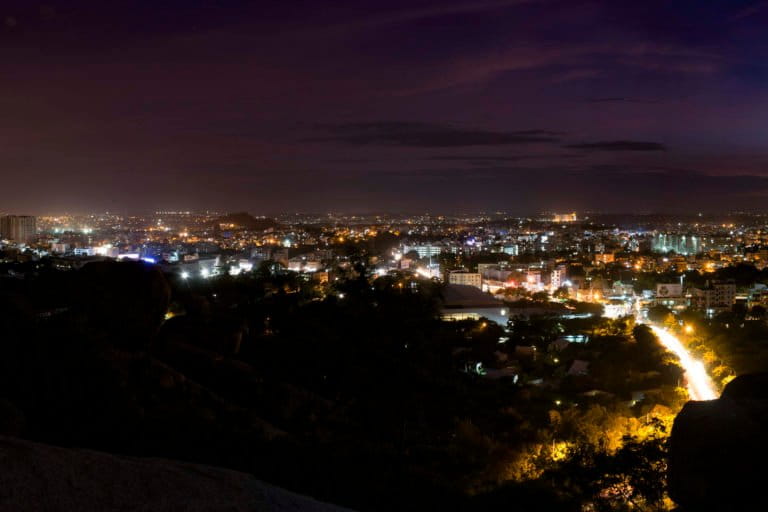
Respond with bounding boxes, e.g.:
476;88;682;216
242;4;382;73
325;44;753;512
668;373;768;511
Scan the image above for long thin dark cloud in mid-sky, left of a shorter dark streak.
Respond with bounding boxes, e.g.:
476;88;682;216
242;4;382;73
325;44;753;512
310;121;560;148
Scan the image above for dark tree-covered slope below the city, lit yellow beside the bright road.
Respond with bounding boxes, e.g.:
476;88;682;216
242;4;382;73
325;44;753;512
0;256;685;510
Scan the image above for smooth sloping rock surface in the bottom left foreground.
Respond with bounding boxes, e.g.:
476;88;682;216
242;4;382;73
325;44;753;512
0;437;346;512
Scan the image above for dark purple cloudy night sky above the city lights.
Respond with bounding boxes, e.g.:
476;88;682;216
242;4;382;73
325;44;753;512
0;0;768;214
